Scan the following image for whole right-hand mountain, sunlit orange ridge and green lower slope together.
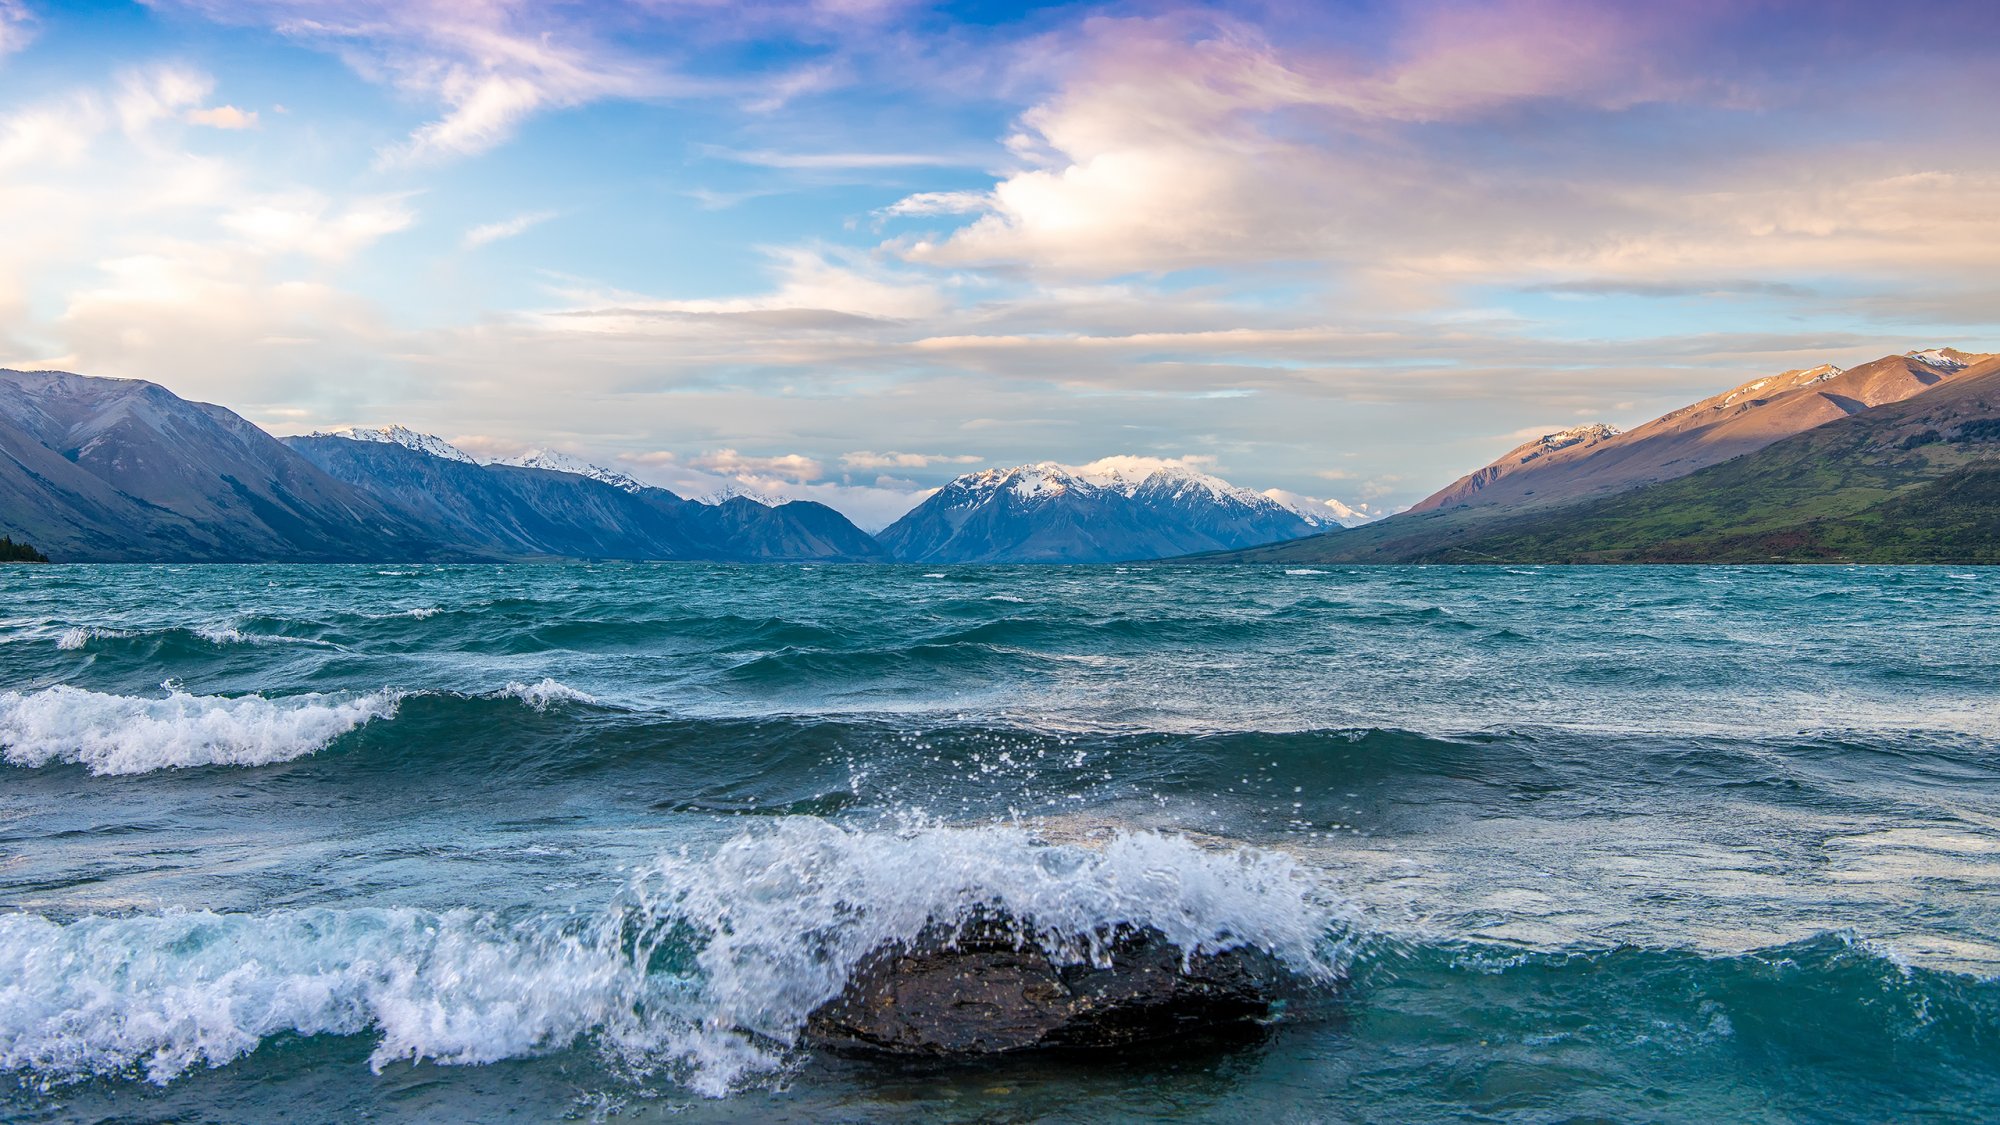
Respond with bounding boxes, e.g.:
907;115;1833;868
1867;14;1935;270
1200;348;2000;565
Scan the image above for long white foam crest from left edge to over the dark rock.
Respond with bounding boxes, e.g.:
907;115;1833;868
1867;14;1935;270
0;817;1336;1097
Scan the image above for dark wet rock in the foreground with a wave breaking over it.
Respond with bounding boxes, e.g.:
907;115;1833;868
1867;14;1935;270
806;915;1286;1057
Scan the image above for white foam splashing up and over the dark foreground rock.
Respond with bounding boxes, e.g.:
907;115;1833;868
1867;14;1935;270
632;817;1340;1095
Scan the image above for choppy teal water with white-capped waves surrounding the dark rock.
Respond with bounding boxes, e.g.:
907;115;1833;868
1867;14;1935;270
0;565;2000;1121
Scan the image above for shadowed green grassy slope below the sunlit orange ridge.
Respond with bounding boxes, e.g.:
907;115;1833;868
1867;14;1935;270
1204;372;2000;563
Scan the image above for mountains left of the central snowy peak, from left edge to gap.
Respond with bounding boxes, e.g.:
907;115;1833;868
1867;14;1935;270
0;370;884;563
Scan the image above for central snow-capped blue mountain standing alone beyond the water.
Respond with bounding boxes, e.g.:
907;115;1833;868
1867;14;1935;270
878;456;1326;563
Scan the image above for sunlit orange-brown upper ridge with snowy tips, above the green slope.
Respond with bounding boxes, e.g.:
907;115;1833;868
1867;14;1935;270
1410;348;2000;512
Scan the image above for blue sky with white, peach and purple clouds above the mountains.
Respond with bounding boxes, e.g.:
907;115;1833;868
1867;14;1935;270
0;0;2000;526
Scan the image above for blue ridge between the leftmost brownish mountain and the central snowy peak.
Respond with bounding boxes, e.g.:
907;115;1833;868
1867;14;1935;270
286;434;882;560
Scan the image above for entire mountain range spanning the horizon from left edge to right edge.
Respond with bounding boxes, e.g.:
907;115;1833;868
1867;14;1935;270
0;348;2000;565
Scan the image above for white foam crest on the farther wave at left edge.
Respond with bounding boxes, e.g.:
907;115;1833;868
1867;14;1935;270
0;685;402;775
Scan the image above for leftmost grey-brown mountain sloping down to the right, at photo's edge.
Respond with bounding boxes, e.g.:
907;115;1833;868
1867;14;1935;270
0;370;440;563
